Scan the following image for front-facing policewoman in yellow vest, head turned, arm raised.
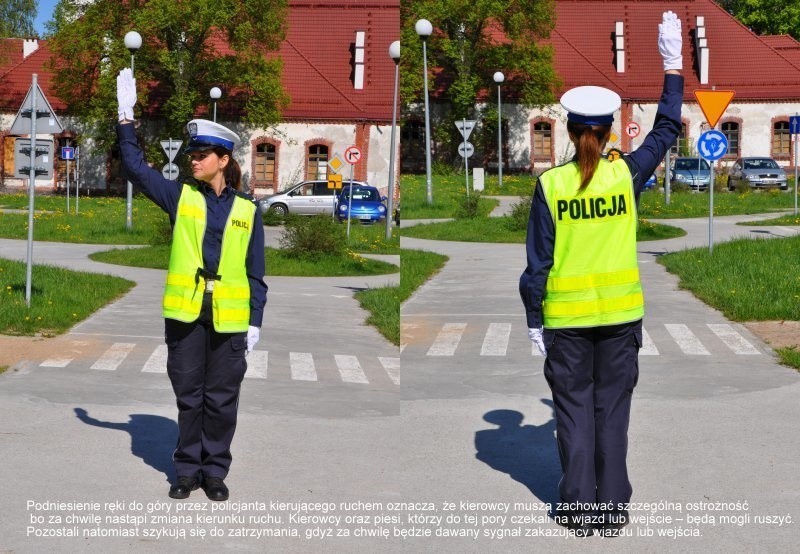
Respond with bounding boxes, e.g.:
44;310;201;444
117;69;267;501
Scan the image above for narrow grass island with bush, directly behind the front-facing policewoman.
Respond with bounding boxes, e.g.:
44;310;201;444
90;245;399;279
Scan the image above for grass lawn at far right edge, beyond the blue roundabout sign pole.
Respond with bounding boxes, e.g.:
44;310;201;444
658;233;800;368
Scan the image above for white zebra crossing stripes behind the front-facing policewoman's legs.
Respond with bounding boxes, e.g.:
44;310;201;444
39;342;400;385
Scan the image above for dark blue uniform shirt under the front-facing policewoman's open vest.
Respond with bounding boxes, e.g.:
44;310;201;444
117;124;267;327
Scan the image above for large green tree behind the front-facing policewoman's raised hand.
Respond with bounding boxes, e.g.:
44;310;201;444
44;0;287;152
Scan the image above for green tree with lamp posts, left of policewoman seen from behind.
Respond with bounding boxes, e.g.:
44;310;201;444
400;0;559;163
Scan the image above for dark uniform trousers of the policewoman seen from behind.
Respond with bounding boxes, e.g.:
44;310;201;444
544;320;642;511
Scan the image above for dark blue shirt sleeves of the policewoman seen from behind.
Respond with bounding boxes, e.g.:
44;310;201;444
519;75;683;328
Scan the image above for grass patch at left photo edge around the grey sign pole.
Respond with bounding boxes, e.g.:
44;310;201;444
0;259;134;336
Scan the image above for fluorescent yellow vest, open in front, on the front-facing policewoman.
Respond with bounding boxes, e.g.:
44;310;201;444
163;184;256;333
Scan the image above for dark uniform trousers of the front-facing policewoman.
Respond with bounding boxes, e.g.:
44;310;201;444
165;294;247;479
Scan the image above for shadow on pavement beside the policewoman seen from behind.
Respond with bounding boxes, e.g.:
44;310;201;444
475;399;561;507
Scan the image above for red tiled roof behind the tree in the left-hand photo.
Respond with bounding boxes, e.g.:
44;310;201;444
0;0;400;121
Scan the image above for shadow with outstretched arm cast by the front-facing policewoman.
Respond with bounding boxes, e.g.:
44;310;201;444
75;408;178;482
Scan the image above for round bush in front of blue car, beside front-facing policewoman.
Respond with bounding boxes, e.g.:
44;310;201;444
278;215;347;259
